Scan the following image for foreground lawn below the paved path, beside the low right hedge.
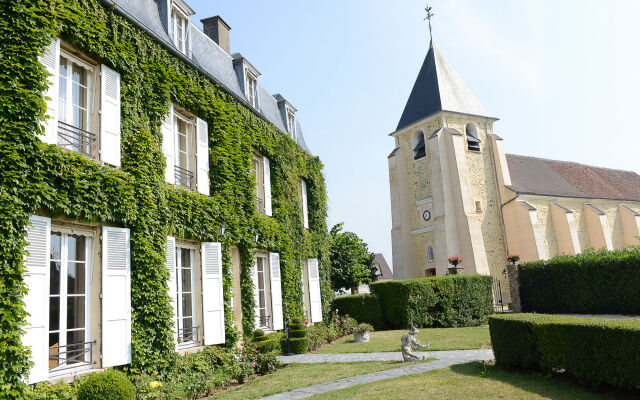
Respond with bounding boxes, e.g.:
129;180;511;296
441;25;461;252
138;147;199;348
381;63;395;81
311;362;611;400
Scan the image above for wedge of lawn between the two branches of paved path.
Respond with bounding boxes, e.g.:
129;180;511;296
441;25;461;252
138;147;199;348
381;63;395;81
212;359;432;399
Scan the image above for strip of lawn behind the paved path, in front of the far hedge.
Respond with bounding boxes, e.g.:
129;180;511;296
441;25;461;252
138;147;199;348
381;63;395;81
318;326;491;353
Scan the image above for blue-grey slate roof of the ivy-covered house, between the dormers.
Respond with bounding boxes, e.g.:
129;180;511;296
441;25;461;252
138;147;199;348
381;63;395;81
102;0;311;153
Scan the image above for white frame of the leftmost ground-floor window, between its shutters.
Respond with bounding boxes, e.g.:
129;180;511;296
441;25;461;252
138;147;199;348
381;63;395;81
47;226;94;377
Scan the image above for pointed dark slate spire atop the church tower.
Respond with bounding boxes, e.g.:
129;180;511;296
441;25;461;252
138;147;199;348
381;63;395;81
396;40;489;130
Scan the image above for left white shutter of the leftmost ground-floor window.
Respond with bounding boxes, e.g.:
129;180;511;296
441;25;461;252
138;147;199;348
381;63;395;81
22;215;51;384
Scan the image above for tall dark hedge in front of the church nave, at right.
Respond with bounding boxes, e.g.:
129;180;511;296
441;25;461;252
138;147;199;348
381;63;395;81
518;250;640;315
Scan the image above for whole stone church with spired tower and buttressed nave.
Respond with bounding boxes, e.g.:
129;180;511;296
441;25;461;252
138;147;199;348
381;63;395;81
388;41;640;286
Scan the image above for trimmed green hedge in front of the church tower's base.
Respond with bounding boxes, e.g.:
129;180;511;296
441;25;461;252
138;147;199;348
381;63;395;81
369;275;493;329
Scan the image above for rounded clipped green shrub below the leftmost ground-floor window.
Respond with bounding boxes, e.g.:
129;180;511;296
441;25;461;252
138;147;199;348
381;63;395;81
78;369;136;400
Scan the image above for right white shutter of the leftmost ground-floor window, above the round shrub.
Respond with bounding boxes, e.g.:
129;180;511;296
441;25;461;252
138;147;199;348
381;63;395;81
102;227;131;368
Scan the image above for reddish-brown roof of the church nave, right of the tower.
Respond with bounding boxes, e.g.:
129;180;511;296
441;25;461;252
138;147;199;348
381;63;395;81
506;154;640;201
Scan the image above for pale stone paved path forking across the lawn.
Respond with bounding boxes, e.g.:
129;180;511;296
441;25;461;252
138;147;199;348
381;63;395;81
264;349;493;400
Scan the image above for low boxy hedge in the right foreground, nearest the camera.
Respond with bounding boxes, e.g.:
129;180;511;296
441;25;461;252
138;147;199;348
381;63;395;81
489;314;640;389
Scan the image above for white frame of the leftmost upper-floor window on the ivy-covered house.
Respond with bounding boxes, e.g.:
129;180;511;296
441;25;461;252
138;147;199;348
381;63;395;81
56;49;98;154
